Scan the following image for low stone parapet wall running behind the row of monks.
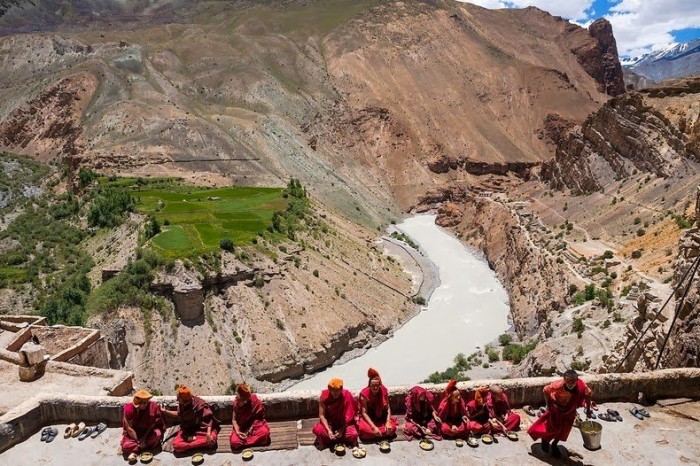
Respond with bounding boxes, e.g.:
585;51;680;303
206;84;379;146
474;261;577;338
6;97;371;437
0;368;700;452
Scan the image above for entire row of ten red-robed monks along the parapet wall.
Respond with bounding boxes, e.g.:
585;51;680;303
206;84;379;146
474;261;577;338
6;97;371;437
122;368;590;459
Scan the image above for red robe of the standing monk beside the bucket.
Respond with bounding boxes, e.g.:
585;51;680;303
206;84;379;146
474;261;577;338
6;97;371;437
527;379;591;442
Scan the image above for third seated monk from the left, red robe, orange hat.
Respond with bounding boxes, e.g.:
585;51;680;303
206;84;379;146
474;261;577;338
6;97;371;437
231;384;270;450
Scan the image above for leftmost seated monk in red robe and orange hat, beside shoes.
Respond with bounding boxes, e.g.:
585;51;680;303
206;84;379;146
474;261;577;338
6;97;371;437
122;390;165;462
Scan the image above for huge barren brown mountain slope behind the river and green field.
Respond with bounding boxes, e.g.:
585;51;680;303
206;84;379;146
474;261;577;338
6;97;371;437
0;0;620;219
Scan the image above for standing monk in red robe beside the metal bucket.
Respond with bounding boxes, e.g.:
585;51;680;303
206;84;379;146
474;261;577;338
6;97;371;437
527;370;592;456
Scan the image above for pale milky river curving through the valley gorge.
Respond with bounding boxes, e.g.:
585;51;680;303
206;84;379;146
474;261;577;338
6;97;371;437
289;215;509;390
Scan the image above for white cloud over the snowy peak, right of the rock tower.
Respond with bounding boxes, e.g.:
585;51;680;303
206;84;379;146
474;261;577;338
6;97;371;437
605;0;700;56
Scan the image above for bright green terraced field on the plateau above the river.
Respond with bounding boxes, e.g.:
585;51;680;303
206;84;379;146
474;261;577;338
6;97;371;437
110;179;287;258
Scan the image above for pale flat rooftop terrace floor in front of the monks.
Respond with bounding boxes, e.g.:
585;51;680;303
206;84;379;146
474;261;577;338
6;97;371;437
0;400;700;466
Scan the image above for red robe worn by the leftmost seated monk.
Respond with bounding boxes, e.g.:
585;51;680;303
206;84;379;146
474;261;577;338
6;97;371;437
122;401;165;455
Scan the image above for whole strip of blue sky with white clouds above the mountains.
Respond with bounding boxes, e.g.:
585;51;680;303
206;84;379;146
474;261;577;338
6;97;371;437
459;0;700;57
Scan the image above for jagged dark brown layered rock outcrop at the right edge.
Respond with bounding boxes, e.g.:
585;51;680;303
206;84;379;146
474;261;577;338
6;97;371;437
542;78;700;194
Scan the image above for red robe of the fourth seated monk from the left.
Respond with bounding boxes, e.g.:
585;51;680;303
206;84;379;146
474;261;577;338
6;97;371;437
313;390;358;450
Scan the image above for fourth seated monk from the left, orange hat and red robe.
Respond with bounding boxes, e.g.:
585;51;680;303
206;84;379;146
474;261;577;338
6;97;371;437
313;379;358;450
